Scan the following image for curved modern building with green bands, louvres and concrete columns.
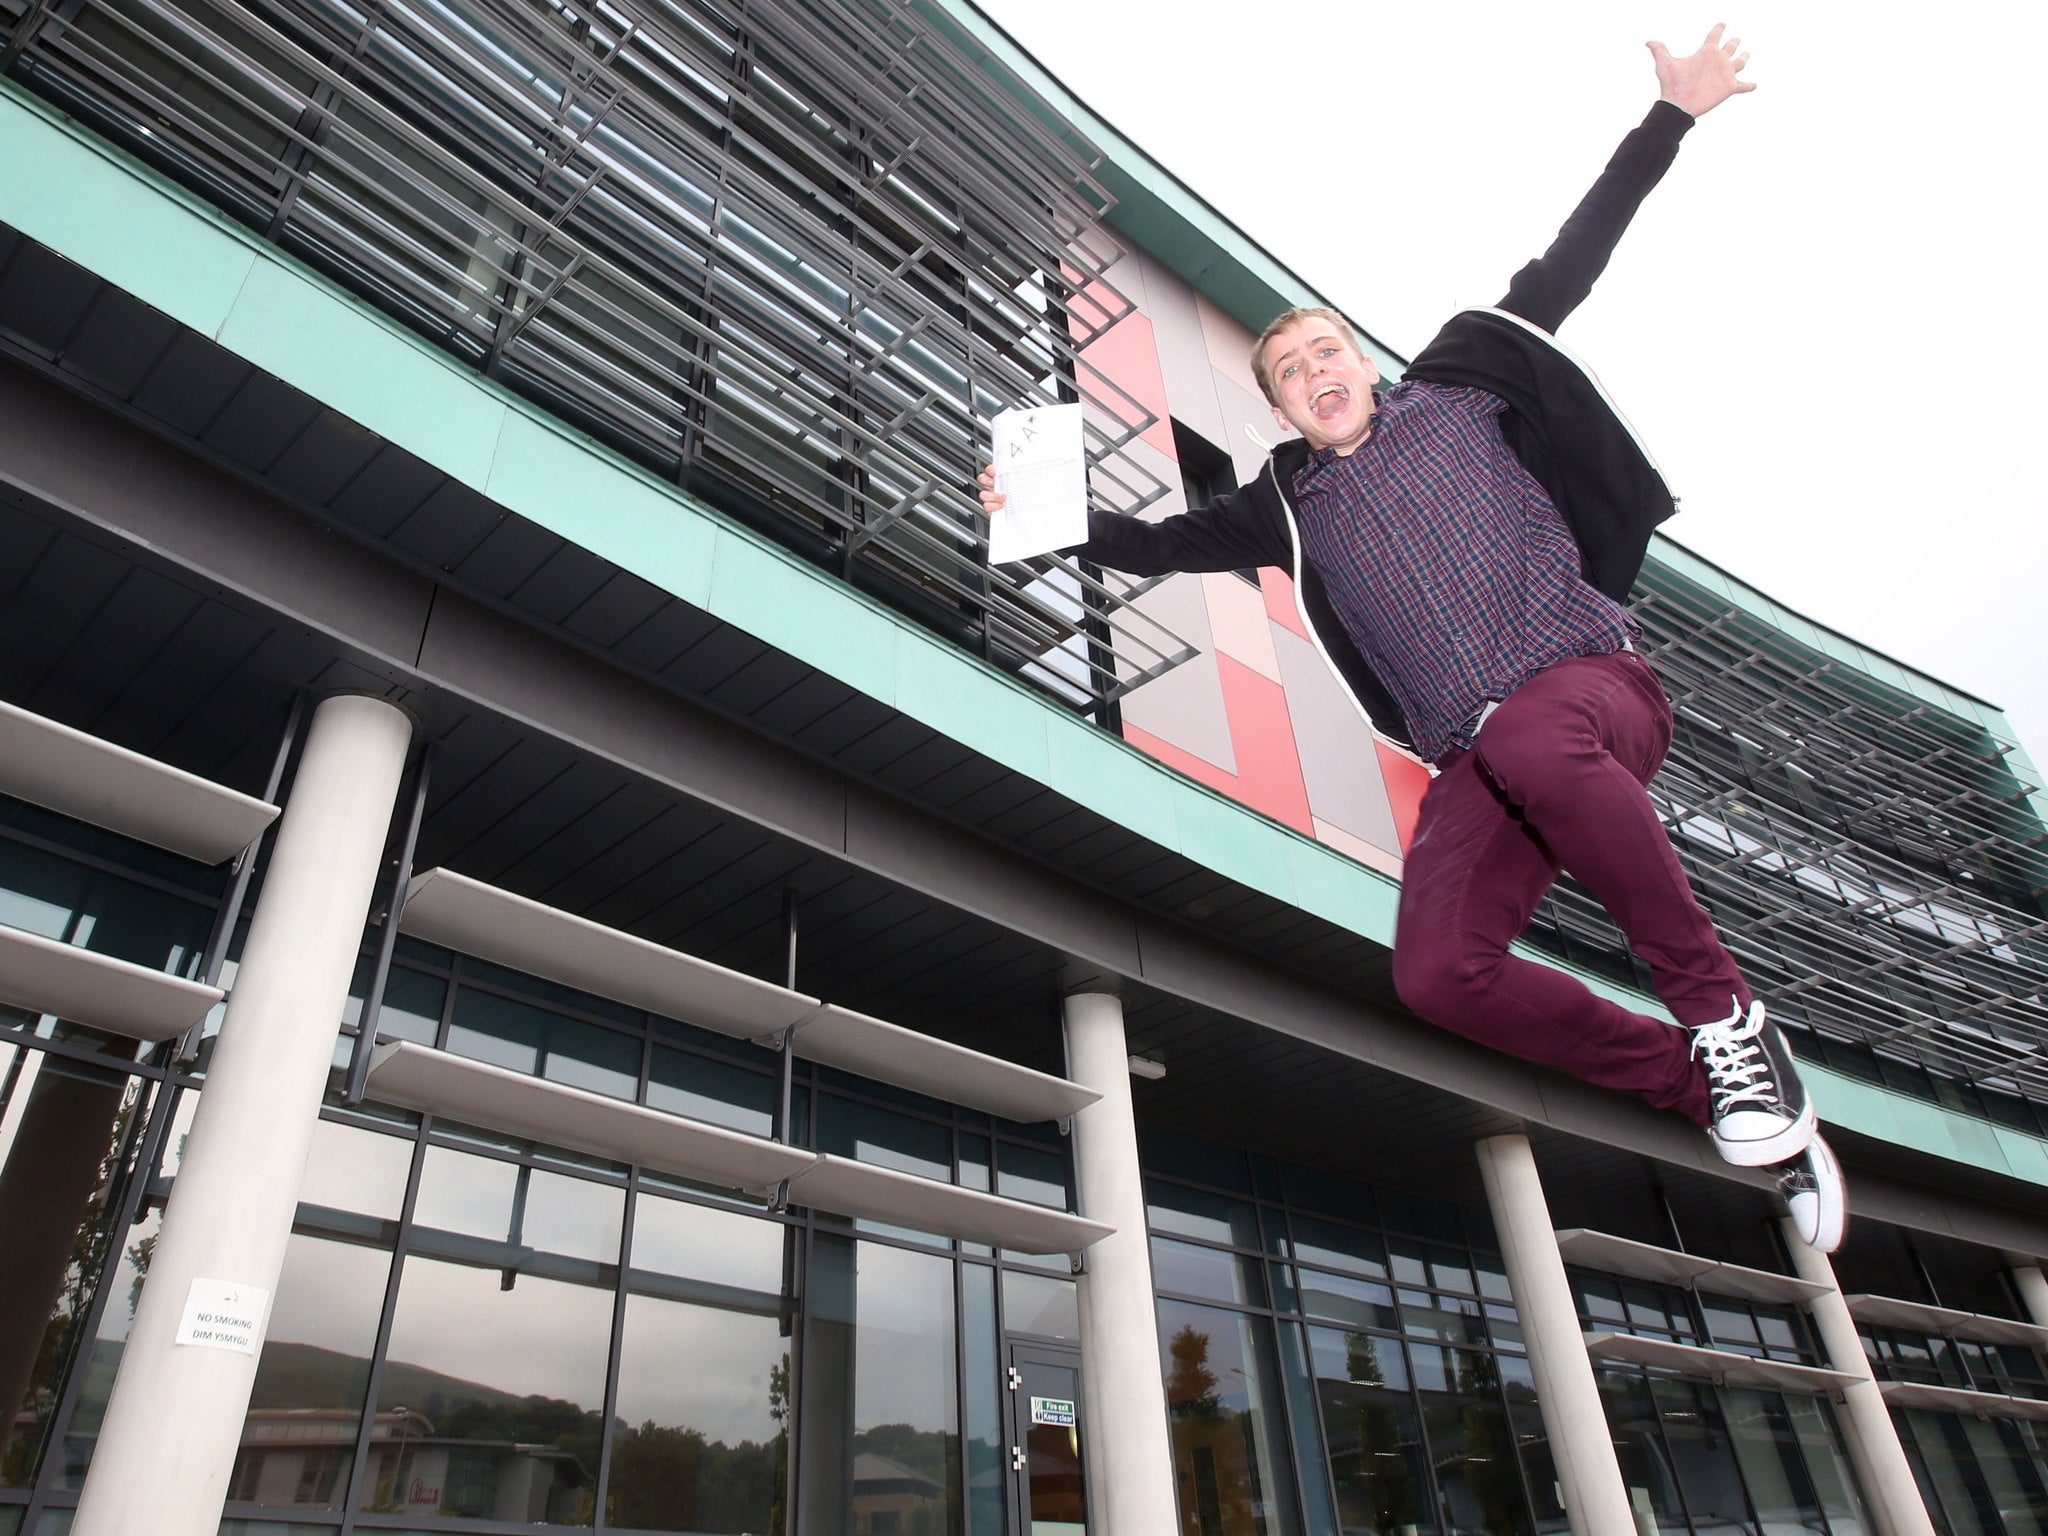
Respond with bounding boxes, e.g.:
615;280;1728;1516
0;0;2048;1536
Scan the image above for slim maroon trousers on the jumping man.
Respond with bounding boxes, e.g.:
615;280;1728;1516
1395;651;1749;1124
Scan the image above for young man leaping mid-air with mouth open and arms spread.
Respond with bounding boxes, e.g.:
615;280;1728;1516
981;27;1845;1251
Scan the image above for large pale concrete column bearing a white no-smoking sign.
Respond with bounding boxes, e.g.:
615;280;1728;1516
72;694;412;1536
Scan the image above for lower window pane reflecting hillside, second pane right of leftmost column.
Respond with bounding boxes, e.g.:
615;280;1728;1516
362;1253;612;1526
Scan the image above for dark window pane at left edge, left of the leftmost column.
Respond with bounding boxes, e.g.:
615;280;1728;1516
0;1044;143;1487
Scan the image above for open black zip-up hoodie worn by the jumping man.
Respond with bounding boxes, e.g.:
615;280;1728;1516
1065;102;1694;748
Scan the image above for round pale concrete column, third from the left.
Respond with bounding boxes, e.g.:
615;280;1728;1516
1479;1135;1636;1536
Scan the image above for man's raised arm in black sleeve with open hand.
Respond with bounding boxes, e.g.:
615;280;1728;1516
1499;27;1755;332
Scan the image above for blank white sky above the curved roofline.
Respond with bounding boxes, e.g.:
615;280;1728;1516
979;0;2048;760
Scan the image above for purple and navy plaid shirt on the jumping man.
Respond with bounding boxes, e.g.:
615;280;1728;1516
1294;381;1634;762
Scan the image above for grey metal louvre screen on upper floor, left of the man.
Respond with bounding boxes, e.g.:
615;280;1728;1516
0;0;1192;707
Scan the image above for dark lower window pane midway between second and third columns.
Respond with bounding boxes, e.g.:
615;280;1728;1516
1309;1327;1434;1536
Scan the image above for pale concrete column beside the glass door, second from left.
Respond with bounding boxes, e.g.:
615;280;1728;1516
1065;991;1180;1536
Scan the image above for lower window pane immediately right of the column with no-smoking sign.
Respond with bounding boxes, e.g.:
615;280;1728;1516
229;1233;391;1509
